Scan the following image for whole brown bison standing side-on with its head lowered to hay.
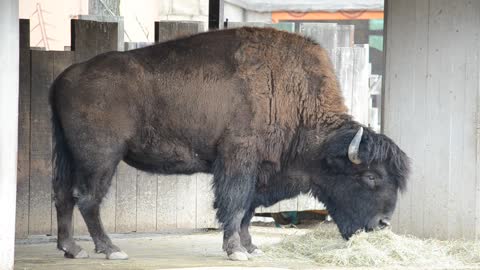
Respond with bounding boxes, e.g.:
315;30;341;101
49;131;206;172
50;28;409;260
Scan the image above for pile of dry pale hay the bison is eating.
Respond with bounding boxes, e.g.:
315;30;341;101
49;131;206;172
263;225;480;268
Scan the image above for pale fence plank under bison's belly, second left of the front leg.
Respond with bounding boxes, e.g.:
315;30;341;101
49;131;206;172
176;175;197;229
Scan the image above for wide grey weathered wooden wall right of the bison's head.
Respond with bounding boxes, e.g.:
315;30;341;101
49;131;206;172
382;0;480;239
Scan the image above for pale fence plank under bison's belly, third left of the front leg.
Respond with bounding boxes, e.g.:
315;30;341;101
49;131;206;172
157;175;177;230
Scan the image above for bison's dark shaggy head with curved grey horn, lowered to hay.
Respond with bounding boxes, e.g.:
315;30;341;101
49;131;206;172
308;126;409;239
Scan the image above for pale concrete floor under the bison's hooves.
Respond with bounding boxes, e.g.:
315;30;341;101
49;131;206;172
15;226;315;270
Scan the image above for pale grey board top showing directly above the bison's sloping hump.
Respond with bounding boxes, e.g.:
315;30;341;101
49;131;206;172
300;22;338;50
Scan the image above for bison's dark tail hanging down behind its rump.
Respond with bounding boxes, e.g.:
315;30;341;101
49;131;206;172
49;79;73;196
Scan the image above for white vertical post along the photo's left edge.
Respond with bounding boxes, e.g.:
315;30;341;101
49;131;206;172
0;0;19;270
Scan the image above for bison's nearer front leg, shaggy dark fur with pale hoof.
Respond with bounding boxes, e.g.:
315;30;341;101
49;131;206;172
214;141;257;261
